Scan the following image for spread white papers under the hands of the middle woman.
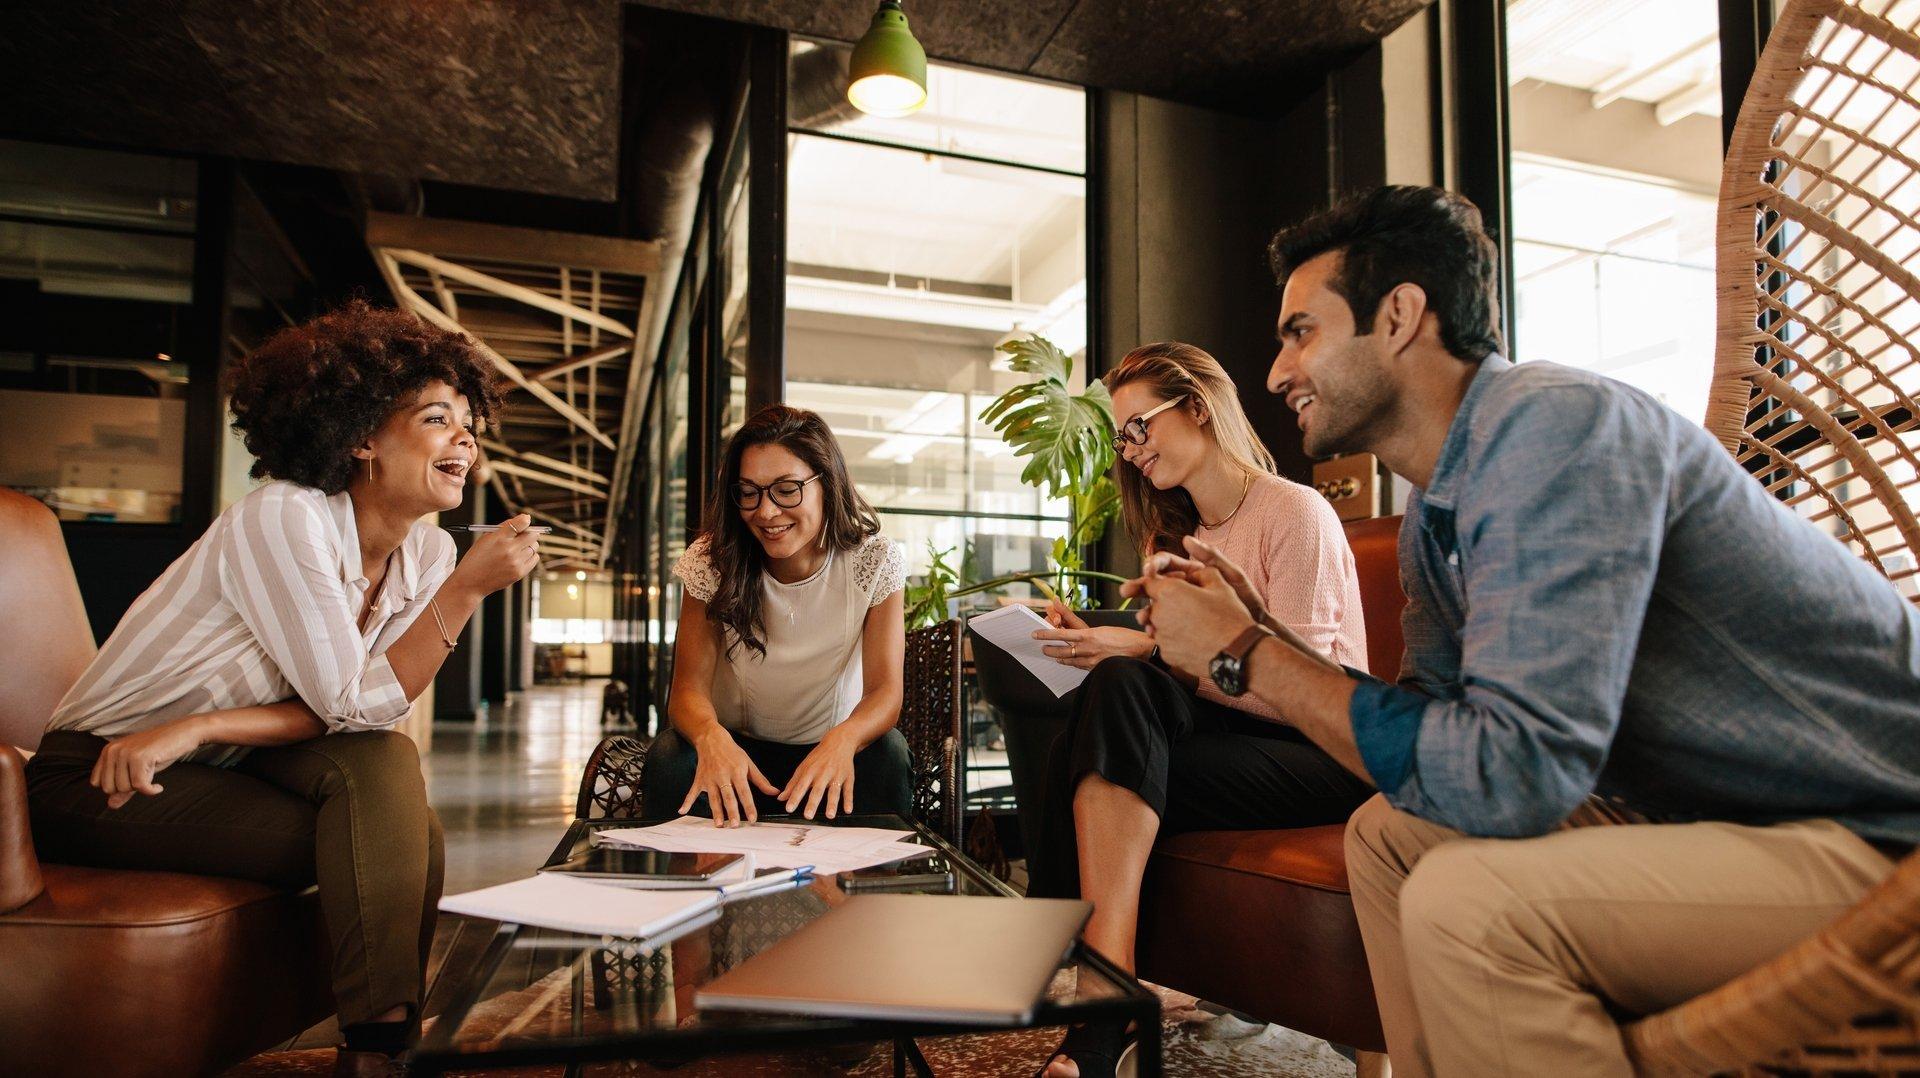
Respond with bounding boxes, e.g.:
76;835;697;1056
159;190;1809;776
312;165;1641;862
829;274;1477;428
595;817;933;876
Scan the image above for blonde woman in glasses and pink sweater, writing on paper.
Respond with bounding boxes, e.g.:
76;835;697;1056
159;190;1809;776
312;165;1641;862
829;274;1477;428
1031;342;1373;1078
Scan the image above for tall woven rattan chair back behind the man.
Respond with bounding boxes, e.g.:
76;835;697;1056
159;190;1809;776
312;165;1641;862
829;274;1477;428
1707;0;1920;598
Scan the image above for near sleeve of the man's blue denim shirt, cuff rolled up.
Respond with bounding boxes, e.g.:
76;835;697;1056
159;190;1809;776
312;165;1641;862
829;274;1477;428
1350;386;1670;836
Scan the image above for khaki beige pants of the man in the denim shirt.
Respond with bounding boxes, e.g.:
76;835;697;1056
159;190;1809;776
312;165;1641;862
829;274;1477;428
1346;797;1893;1078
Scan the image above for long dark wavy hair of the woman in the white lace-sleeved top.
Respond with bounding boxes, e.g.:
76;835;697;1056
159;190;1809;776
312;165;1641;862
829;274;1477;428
701;404;879;659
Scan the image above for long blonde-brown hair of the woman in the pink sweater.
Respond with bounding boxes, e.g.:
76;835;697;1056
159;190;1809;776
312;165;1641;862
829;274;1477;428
1102;340;1277;553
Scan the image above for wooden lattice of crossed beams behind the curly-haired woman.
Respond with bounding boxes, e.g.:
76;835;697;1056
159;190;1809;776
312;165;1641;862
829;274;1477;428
365;204;662;567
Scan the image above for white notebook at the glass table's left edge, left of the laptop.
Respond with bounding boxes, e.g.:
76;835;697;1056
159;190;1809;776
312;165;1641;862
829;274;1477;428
440;872;720;938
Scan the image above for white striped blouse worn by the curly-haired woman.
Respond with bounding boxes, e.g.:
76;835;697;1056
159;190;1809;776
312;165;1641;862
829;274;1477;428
46;482;455;765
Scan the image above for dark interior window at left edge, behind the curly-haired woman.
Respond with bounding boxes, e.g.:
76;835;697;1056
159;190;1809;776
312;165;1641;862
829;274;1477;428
0;140;198;525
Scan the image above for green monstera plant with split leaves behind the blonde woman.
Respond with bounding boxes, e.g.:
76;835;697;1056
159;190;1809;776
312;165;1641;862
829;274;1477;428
906;334;1123;628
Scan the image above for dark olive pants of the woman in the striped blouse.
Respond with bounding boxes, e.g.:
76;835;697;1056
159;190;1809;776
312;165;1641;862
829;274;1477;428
27;730;445;1026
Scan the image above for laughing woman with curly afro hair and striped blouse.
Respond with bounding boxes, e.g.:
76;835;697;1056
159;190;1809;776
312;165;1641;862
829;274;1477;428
29;300;538;1074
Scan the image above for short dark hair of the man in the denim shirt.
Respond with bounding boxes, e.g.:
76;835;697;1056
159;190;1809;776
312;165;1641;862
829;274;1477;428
1267;186;1501;363
